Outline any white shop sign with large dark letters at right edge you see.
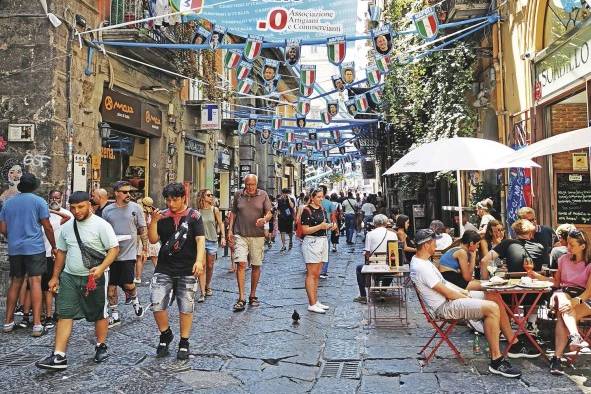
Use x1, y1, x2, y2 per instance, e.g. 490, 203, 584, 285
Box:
534, 26, 591, 100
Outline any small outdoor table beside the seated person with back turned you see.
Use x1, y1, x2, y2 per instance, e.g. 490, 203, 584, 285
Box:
361, 263, 410, 326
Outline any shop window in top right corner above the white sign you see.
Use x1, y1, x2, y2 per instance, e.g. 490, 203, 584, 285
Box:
544, 0, 591, 47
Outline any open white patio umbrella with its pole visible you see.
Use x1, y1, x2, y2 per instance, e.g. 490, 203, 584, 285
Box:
384, 137, 540, 232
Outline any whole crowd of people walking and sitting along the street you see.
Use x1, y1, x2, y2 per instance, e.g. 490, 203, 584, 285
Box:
0, 174, 591, 377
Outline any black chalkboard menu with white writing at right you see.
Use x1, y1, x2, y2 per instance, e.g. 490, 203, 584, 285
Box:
556, 173, 591, 224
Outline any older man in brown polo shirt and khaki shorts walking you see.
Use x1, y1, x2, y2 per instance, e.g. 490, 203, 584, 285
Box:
228, 174, 272, 311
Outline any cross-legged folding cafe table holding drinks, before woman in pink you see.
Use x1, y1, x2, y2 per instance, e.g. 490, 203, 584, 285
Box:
483, 286, 552, 361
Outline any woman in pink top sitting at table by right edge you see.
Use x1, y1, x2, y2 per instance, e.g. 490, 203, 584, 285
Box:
530, 230, 591, 375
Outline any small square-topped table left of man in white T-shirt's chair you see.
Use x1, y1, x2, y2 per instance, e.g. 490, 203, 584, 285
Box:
361, 264, 410, 327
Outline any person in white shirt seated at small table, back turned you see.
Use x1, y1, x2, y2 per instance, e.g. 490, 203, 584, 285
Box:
353, 214, 398, 303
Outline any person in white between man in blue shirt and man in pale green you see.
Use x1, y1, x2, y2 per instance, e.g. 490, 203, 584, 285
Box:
41, 190, 72, 329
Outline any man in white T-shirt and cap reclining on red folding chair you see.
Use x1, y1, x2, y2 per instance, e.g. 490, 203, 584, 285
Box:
410, 229, 539, 378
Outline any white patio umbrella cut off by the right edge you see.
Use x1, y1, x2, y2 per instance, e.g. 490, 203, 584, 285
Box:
505, 127, 591, 163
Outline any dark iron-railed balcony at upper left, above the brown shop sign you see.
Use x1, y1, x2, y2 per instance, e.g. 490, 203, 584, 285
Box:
99, 0, 196, 73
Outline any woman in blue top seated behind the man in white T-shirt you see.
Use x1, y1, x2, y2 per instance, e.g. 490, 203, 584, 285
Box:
439, 230, 481, 290
